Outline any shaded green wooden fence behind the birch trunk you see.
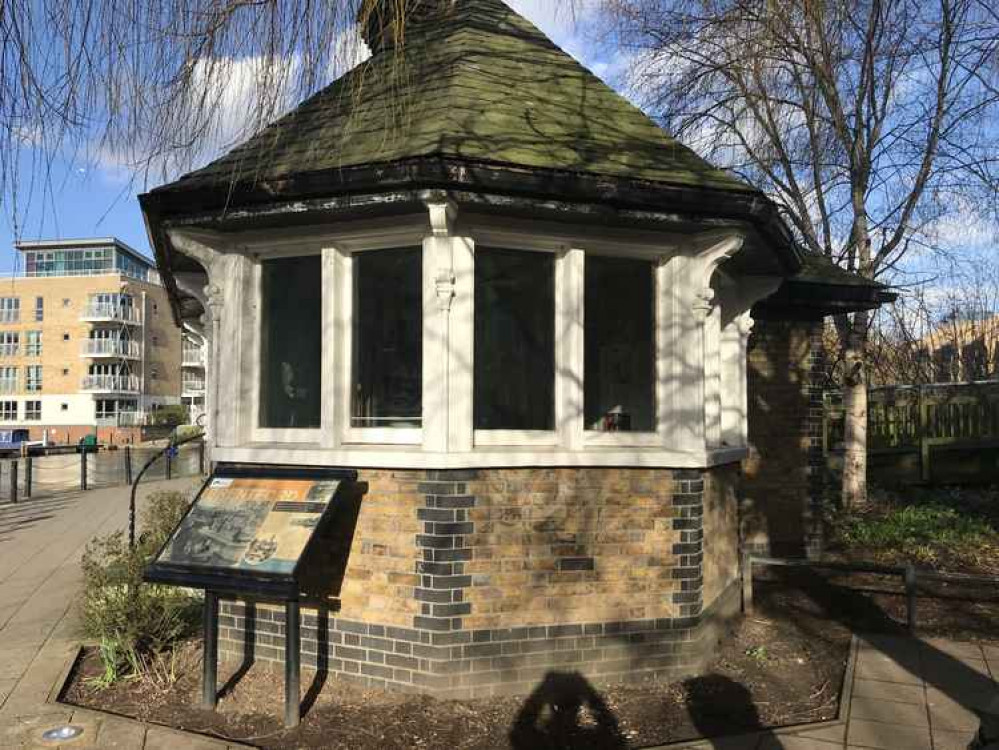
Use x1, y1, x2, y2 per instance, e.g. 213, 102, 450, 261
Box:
822, 382, 999, 484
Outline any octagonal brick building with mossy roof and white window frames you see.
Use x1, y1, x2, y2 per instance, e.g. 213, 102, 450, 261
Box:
141, 0, 887, 696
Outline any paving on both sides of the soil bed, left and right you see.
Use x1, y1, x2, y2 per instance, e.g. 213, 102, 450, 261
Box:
0, 478, 999, 750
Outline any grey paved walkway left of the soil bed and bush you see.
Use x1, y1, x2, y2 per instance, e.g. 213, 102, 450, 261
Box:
0, 477, 238, 750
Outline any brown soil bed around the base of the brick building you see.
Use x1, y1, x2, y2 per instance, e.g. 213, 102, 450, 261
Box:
63, 584, 850, 750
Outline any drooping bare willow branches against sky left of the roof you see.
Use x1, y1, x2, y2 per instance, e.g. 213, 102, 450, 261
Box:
0, 0, 438, 233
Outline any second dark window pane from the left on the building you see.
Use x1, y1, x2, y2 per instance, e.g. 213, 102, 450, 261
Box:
351, 248, 423, 427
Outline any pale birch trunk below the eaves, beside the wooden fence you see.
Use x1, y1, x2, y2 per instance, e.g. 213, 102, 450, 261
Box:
842, 312, 868, 508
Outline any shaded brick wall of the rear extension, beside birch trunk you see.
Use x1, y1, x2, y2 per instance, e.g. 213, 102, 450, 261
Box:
741, 320, 825, 555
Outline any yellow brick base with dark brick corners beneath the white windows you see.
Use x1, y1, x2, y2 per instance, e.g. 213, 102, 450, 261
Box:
220, 467, 739, 697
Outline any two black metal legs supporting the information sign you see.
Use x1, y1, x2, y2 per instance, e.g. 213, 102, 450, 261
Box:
201, 591, 302, 729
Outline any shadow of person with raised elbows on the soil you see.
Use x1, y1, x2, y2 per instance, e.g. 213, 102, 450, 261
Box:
510, 672, 628, 750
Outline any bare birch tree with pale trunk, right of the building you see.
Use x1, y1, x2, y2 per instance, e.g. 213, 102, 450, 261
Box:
603, 0, 999, 504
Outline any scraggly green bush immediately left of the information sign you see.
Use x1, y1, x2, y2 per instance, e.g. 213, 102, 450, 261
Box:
81, 492, 200, 687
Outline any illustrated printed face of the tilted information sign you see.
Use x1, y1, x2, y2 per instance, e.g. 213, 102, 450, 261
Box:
158, 477, 340, 575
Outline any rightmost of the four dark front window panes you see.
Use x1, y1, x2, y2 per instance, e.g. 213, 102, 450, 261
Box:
583, 256, 655, 432
